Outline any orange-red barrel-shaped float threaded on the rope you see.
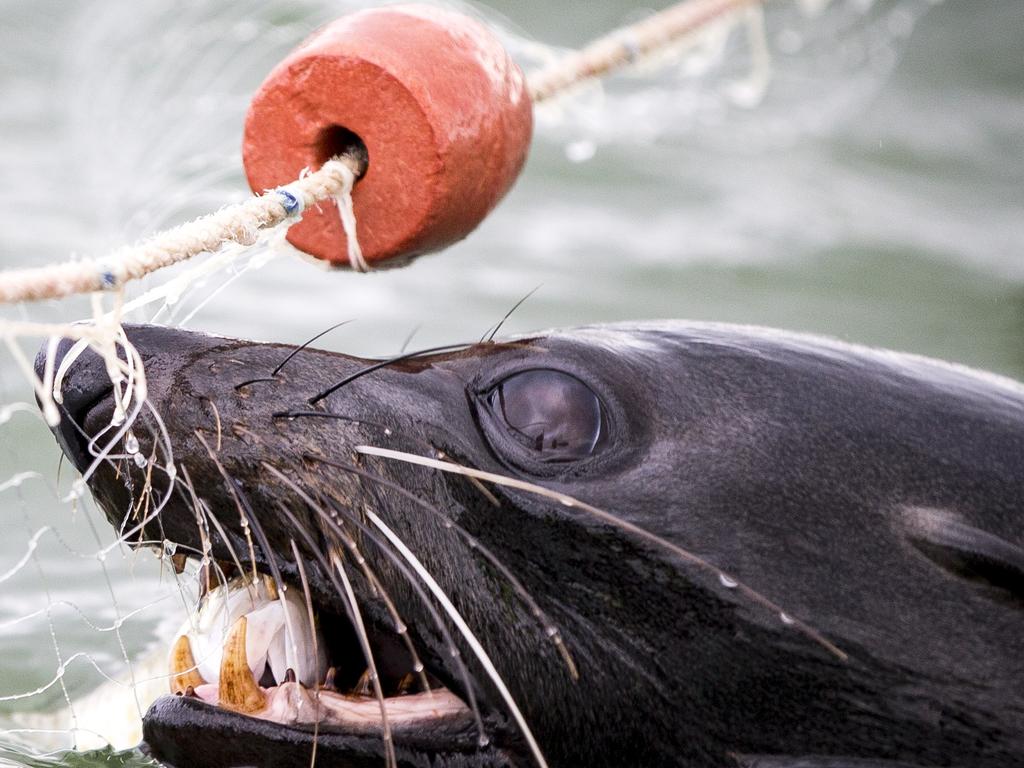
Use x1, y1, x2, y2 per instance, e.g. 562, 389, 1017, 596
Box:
243, 5, 532, 265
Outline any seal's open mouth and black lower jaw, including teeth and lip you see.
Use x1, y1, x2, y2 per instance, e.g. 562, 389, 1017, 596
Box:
143, 563, 487, 765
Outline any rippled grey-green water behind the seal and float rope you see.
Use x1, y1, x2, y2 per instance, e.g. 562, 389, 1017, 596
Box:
0, 0, 1024, 765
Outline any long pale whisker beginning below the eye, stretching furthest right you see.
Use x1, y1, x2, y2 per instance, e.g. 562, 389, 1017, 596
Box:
352, 445, 849, 662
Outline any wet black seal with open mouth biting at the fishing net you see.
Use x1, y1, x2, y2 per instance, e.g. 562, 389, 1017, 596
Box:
37, 323, 1024, 768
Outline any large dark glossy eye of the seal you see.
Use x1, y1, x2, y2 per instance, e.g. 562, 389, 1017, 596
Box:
486, 369, 604, 462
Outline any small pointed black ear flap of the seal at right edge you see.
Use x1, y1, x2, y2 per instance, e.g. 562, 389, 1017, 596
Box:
903, 507, 1024, 604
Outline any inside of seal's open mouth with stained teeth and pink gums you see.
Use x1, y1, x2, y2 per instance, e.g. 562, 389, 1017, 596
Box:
146, 561, 481, 757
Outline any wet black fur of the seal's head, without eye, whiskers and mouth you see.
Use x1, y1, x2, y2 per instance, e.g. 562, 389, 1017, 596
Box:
36, 324, 1024, 768
